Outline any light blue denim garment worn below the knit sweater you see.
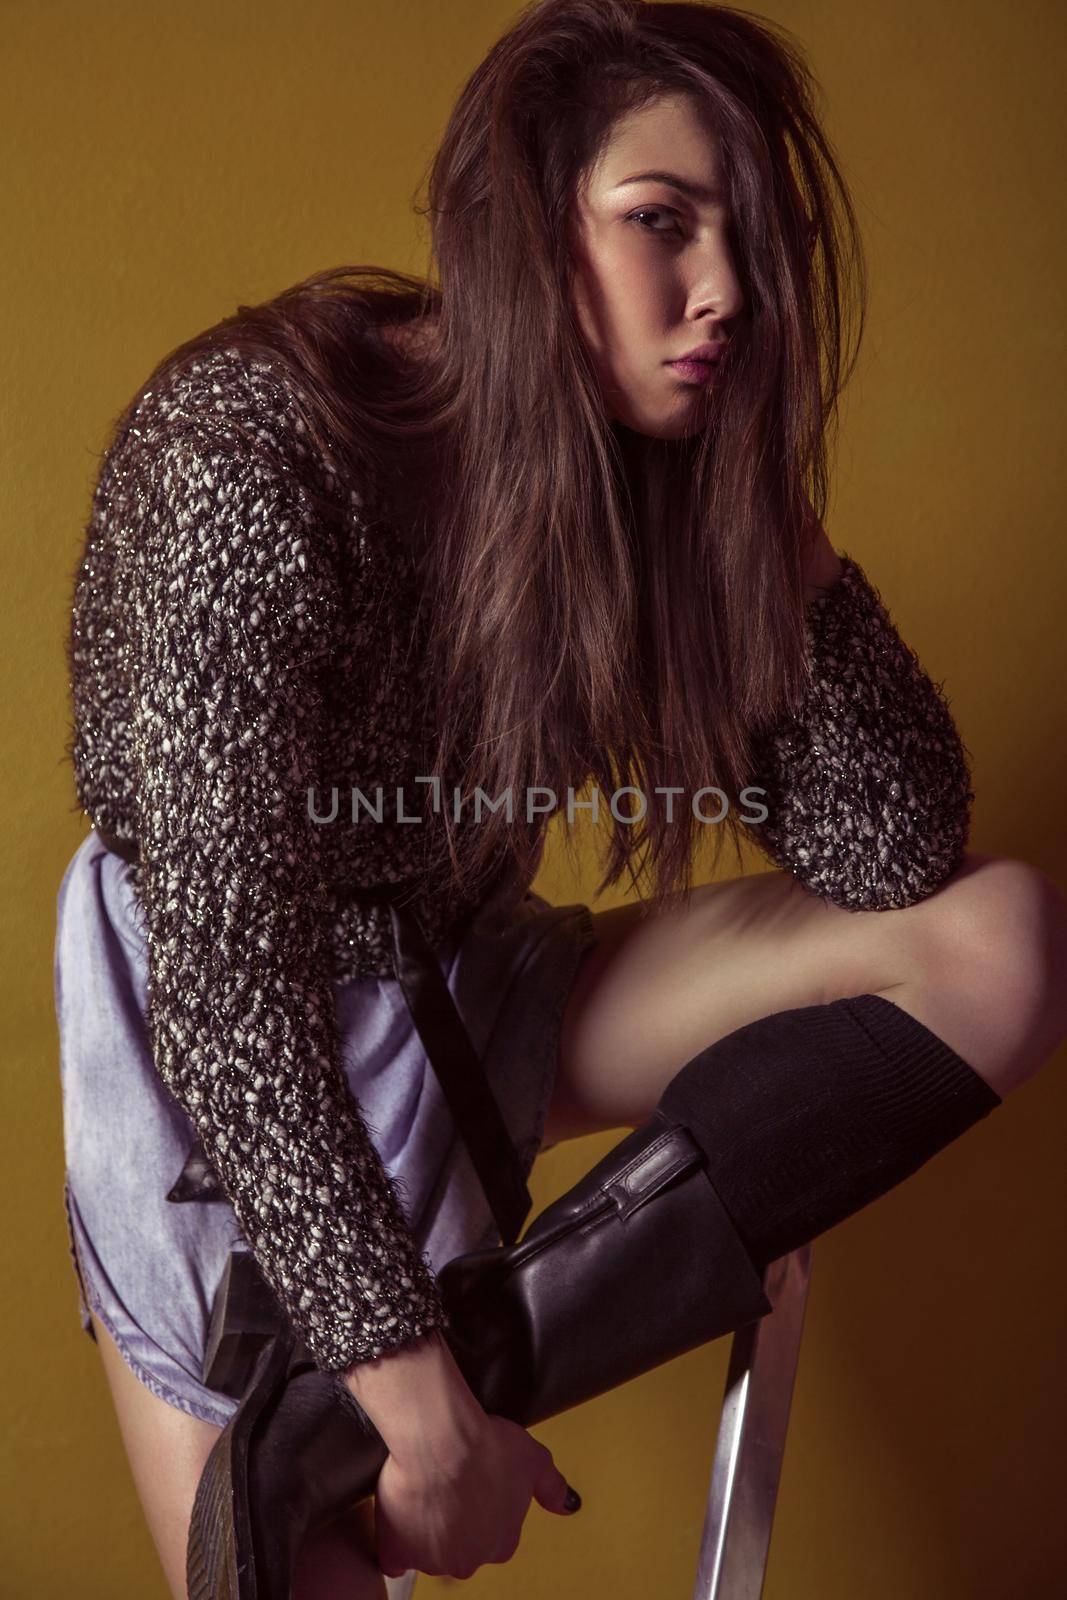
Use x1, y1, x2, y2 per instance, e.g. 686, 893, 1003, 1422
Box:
54, 832, 595, 1427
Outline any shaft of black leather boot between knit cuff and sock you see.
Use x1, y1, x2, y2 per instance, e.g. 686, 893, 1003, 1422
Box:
438, 1110, 771, 1426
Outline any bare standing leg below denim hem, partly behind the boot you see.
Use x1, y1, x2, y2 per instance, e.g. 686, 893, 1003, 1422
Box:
90, 1312, 387, 1600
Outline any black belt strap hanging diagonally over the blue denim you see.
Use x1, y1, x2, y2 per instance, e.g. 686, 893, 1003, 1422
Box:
96, 827, 533, 1245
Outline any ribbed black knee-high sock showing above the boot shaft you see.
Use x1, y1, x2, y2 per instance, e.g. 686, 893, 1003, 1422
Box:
659, 994, 1001, 1269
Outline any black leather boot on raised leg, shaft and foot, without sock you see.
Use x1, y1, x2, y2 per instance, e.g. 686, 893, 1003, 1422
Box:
187, 1114, 771, 1600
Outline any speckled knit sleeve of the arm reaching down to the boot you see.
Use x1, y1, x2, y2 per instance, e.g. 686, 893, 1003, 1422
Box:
116, 380, 448, 1371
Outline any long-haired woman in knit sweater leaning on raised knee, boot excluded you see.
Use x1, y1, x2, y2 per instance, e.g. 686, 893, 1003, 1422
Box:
56, 0, 1067, 1600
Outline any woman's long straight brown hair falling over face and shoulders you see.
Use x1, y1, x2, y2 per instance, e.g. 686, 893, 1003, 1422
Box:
97, 0, 867, 904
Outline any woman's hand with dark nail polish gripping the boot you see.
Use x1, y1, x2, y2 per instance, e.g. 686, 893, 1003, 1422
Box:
374, 1411, 581, 1578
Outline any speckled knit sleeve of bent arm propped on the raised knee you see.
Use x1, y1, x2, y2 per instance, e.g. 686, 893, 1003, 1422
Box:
749, 555, 974, 910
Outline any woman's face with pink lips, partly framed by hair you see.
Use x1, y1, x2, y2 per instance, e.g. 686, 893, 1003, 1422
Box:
573, 94, 744, 438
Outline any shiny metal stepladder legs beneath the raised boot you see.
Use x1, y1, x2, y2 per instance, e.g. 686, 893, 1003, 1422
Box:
386, 1245, 811, 1600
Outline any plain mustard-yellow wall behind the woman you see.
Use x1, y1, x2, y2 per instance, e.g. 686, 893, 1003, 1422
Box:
0, 0, 1067, 1600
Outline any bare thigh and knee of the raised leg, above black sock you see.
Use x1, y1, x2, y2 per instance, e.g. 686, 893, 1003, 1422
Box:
544, 854, 1036, 1146
